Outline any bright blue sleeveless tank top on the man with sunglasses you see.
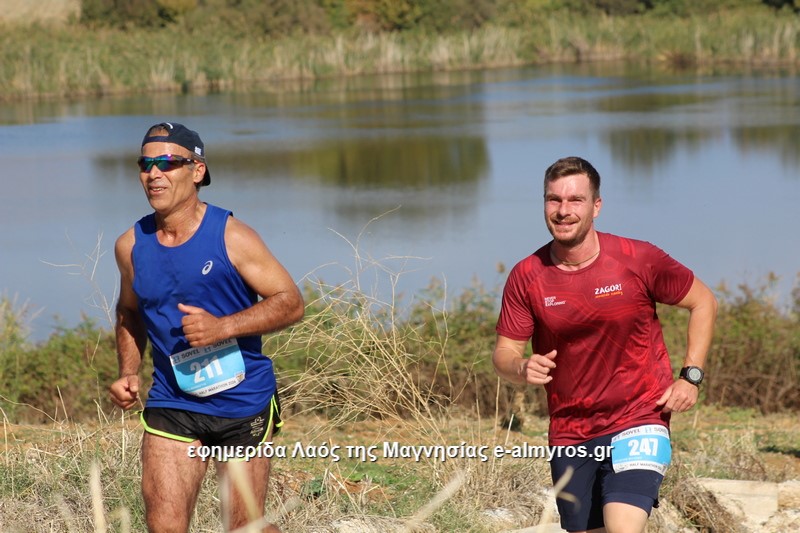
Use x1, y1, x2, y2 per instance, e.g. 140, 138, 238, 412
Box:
133, 204, 276, 418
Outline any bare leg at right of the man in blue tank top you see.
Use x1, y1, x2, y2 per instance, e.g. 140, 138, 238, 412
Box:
215, 457, 280, 533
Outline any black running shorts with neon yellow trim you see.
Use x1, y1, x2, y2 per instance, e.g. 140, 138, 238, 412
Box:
140, 392, 283, 446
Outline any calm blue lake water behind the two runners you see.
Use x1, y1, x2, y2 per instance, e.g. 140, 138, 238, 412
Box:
0, 60, 800, 339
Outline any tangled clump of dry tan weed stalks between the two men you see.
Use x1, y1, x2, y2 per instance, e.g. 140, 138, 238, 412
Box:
276, 211, 447, 442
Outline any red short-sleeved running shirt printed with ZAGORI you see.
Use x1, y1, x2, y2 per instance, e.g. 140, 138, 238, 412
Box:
496, 232, 694, 446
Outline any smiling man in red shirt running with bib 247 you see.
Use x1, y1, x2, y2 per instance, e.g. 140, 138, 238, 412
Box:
492, 157, 717, 533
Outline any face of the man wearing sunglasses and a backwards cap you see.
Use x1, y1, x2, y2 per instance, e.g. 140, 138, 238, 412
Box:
139, 142, 206, 214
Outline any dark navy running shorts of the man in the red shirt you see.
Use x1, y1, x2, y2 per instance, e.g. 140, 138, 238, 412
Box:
550, 433, 664, 531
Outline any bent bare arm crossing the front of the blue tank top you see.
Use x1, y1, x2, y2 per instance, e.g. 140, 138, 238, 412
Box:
178, 217, 304, 346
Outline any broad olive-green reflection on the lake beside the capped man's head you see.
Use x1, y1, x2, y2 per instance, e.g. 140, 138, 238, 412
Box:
93, 132, 491, 231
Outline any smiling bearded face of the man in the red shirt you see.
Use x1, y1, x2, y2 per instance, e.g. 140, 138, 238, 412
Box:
544, 174, 602, 248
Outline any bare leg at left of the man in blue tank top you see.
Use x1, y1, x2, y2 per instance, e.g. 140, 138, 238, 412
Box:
142, 432, 208, 533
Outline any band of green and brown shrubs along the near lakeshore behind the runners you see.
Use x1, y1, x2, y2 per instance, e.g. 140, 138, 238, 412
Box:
0, 268, 800, 422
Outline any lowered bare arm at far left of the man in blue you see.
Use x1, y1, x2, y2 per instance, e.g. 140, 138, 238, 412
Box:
109, 229, 147, 409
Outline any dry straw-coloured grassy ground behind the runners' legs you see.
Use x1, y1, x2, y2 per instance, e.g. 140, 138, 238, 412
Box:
0, 407, 800, 533
